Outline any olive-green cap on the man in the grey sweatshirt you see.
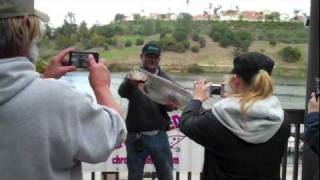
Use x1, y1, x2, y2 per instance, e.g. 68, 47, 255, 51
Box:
0, 0, 50, 22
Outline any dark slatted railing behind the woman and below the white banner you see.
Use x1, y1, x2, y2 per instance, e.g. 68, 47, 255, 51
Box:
91, 109, 305, 180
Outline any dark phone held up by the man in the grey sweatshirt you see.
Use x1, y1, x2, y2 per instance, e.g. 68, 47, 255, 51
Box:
68, 52, 99, 68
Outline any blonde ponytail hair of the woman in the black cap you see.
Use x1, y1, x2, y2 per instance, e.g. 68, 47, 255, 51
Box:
231, 70, 273, 115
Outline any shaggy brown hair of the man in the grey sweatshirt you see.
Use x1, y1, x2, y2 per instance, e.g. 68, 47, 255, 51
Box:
0, 16, 40, 58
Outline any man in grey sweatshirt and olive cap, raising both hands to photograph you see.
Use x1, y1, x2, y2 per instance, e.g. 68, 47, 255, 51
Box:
0, 0, 127, 180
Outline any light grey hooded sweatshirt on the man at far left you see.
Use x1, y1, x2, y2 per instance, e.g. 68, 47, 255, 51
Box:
0, 57, 127, 180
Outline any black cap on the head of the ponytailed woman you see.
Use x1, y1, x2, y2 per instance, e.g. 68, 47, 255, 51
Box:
231, 52, 274, 84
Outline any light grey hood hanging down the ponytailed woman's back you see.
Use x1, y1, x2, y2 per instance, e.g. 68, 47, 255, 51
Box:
212, 96, 284, 144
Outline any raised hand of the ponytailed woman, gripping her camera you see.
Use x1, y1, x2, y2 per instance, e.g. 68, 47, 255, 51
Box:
193, 79, 211, 102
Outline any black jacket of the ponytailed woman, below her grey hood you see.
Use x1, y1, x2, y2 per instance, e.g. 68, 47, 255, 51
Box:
180, 100, 290, 180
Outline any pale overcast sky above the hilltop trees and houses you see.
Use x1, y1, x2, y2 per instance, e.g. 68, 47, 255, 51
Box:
35, 0, 310, 26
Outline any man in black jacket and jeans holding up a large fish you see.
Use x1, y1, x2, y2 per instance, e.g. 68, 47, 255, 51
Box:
118, 43, 176, 180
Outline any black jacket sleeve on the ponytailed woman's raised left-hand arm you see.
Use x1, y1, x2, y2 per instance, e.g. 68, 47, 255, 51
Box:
180, 100, 219, 149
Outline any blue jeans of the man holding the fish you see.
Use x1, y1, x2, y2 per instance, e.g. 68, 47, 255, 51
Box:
126, 131, 173, 180
